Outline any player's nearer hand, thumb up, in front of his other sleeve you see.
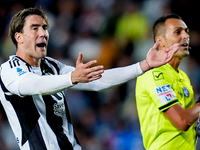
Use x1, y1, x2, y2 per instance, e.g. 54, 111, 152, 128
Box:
71, 53, 104, 84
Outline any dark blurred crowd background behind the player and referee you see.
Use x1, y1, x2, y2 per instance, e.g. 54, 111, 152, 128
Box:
0, 0, 200, 150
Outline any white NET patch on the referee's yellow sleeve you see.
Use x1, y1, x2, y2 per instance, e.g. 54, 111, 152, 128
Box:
155, 84, 176, 104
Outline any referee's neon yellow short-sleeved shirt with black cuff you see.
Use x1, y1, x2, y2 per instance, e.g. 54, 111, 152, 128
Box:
136, 64, 196, 150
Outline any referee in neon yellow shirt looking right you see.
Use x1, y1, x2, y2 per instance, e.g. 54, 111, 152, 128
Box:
136, 14, 200, 150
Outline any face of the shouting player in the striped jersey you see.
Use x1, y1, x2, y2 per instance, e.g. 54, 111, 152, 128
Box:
22, 15, 49, 59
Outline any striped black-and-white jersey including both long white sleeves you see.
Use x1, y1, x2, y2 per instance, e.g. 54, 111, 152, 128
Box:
0, 56, 143, 150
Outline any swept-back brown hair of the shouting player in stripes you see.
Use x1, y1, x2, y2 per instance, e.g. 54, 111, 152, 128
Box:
9, 8, 49, 47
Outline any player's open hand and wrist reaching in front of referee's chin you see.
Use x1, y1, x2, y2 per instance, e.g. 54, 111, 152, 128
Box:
140, 42, 180, 72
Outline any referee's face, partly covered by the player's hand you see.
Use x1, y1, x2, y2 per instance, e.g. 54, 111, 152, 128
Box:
164, 18, 189, 58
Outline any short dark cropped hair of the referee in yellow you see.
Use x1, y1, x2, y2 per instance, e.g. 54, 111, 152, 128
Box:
153, 13, 182, 41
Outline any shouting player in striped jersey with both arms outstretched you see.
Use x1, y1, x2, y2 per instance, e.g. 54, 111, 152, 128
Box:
0, 8, 180, 150
